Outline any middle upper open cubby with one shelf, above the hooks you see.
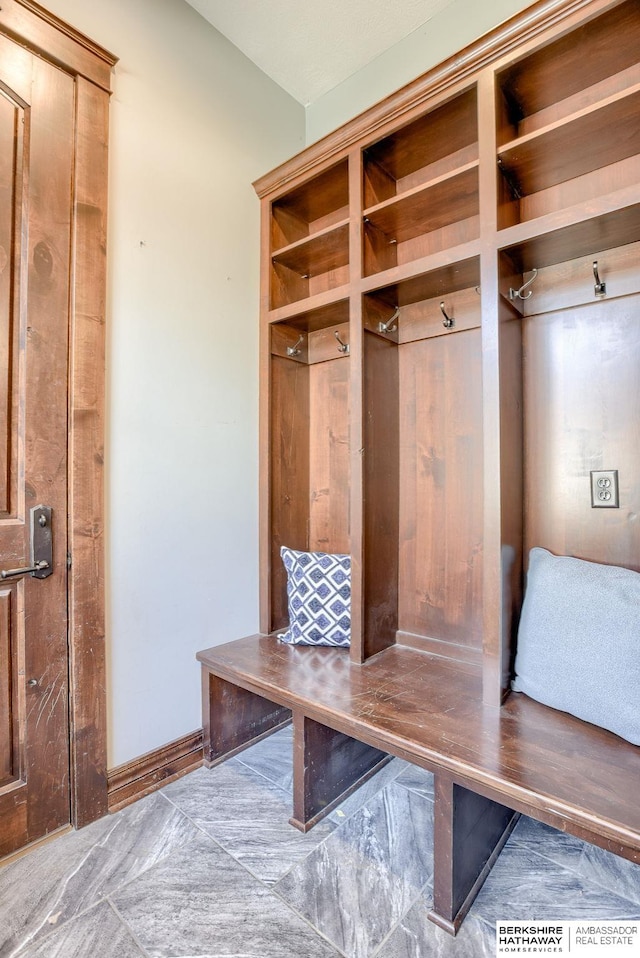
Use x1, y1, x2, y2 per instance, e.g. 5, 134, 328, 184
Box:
363, 86, 479, 276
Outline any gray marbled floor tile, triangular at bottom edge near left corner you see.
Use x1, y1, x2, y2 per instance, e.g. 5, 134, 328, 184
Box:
14, 901, 144, 958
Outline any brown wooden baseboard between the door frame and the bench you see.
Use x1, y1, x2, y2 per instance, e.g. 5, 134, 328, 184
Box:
107, 729, 203, 812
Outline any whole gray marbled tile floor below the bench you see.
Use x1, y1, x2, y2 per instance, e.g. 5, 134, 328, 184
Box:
0, 729, 640, 958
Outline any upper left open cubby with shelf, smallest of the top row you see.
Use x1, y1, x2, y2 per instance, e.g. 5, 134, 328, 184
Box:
271, 160, 349, 309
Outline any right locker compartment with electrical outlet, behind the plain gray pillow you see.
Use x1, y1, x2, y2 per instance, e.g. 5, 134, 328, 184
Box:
492, 215, 640, 691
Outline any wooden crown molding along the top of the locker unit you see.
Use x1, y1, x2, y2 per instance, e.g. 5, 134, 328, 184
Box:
253, 0, 611, 199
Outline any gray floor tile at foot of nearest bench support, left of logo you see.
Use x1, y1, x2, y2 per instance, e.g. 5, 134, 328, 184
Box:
375, 899, 496, 958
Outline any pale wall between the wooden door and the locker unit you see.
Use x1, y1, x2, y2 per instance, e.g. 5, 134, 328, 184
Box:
46, 0, 304, 767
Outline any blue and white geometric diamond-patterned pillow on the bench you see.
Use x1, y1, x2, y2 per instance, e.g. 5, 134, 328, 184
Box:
279, 546, 351, 649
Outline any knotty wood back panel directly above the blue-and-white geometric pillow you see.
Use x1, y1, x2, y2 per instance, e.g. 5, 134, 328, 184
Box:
308, 358, 350, 553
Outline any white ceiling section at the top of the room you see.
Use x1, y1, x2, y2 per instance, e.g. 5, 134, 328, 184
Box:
182, 0, 453, 106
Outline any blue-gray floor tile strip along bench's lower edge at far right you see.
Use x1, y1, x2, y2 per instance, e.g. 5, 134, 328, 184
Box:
509, 815, 640, 906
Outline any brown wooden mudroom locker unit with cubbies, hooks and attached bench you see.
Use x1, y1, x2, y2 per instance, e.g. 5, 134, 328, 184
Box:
198, 0, 640, 933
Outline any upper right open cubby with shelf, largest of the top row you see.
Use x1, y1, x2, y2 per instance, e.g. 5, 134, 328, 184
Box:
497, 0, 640, 229
